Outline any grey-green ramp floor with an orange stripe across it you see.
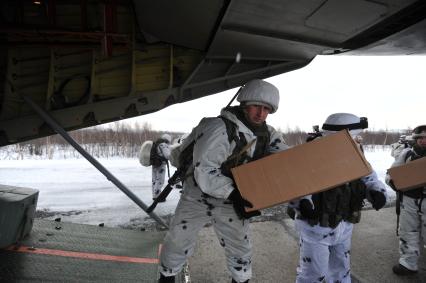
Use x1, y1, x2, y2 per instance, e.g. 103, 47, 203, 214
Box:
0, 219, 165, 282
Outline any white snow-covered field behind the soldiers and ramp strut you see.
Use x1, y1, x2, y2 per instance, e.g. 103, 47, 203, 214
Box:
0, 147, 395, 227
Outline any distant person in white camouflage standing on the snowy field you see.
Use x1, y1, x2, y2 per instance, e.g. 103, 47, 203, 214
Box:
150, 134, 172, 200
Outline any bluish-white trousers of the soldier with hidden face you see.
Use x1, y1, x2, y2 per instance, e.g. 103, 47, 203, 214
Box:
296, 220, 353, 283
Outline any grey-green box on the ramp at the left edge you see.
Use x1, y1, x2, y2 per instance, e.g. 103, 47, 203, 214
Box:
0, 185, 38, 249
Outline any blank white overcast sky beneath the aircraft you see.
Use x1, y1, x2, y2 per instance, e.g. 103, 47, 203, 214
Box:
121, 56, 426, 135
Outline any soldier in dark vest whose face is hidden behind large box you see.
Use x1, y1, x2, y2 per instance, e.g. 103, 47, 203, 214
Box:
289, 113, 386, 283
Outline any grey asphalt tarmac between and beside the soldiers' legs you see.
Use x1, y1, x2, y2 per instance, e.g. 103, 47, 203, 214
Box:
189, 207, 426, 283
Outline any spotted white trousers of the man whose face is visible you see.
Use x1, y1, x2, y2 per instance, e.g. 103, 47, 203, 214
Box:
160, 192, 252, 282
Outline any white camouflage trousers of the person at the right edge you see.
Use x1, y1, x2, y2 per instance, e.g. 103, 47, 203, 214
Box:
399, 195, 426, 270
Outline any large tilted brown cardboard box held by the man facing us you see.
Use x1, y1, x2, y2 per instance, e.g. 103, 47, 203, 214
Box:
232, 130, 371, 211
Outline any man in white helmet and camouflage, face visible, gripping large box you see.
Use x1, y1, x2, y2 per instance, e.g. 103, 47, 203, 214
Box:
159, 80, 287, 282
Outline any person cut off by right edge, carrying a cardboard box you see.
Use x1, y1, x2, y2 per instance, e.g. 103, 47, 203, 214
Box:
386, 125, 426, 276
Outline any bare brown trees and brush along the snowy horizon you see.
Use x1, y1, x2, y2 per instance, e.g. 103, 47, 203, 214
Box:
2, 122, 410, 159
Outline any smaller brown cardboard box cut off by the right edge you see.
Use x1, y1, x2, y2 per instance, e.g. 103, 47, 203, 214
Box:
388, 157, 426, 191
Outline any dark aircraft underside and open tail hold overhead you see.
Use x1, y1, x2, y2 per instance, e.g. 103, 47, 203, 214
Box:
0, 0, 426, 146
